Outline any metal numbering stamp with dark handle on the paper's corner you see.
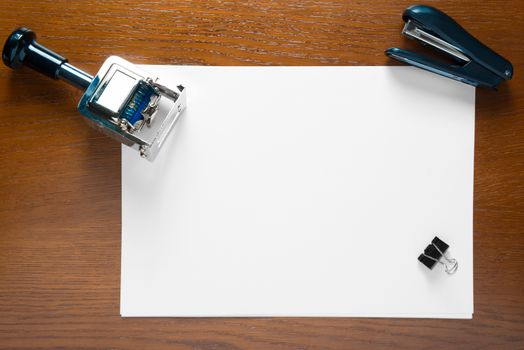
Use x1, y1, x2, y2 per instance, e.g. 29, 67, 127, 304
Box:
2, 28, 186, 160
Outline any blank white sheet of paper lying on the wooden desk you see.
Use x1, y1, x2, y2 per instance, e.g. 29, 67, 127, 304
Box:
121, 66, 475, 318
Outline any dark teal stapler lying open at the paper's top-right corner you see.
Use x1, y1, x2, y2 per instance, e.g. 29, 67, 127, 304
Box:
385, 5, 513, 89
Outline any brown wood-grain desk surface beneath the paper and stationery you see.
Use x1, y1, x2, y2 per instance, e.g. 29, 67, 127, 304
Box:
0, 0, 524, 350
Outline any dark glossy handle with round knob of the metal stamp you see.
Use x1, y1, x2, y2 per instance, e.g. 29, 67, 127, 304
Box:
2, 27, 93, 90
